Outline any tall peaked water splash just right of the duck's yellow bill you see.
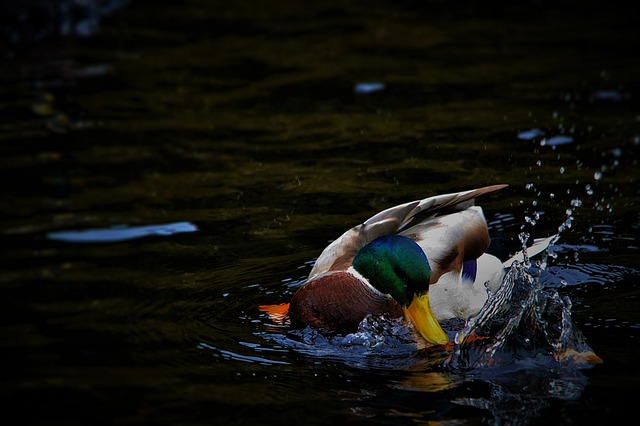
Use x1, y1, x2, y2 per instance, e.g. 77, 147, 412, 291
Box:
446, 262, 601, 370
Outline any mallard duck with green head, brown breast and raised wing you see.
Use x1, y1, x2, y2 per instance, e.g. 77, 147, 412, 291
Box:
261, 184, 555, 346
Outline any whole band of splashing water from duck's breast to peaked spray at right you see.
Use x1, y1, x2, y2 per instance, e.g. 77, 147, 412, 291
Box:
260, 258, 601, 372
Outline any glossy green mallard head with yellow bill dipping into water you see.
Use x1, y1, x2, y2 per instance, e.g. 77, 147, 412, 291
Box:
352, 235, 449, 345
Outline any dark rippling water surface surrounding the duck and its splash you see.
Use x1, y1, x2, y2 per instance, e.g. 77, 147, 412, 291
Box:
0, 0, 640, 424
